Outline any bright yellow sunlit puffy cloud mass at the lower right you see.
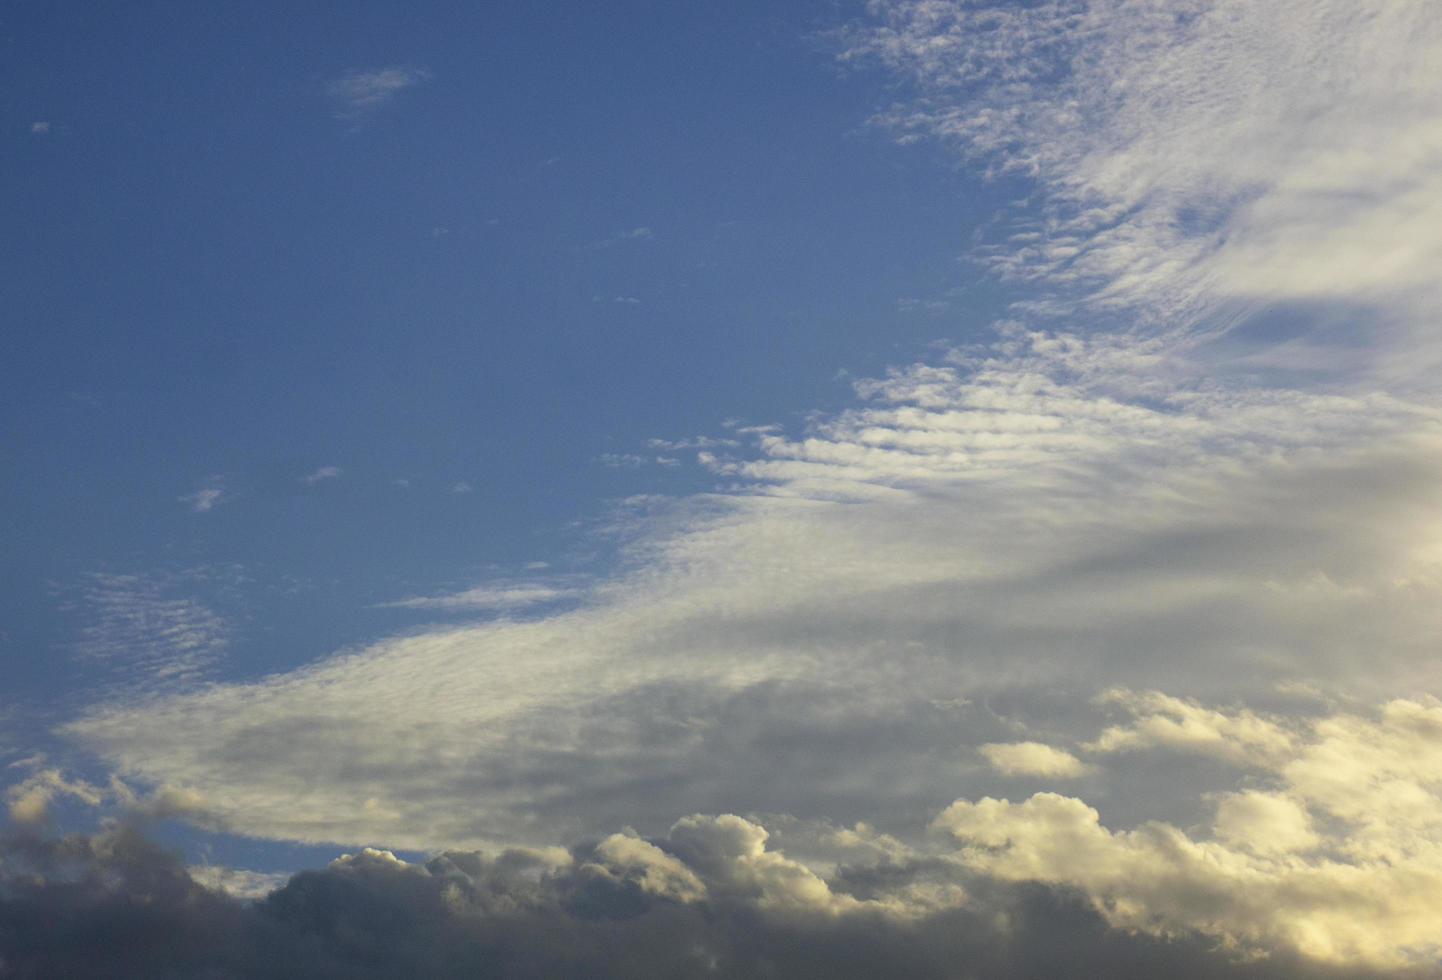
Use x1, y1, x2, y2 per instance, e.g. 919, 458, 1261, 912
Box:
934, 695, 1442, 967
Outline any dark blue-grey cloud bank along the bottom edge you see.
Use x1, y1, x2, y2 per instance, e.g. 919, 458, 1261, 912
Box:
0, 827, 1418, 980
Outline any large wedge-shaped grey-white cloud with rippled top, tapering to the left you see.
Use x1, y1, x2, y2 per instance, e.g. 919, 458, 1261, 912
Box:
66, 343, 1442, 849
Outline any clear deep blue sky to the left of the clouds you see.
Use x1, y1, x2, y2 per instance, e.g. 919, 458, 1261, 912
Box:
4, 4, 1015, 693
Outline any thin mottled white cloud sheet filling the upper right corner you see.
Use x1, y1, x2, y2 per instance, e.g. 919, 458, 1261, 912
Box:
839, 0, 1442, 380
